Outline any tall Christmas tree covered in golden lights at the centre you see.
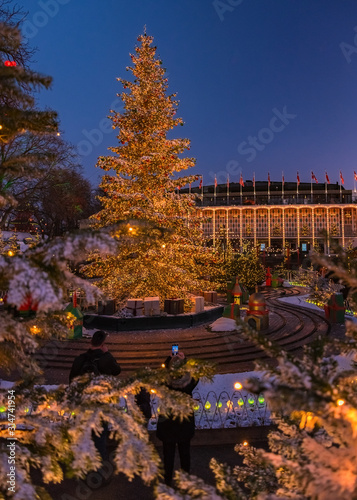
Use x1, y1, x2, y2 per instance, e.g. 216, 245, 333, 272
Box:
85, 34, 219, 300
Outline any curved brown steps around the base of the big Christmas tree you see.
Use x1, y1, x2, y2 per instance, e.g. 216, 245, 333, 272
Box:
40, 288, 331, 383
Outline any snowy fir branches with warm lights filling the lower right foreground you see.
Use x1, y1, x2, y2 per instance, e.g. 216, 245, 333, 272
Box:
162, 244, 357, 500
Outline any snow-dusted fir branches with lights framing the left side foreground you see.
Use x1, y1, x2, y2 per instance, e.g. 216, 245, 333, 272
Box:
0, 13, 214, 500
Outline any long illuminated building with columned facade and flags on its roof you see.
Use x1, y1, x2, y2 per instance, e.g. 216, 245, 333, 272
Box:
182, 181, 357, 254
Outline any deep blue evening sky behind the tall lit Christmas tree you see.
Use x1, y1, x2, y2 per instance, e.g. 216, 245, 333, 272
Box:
19, 0, 357, 188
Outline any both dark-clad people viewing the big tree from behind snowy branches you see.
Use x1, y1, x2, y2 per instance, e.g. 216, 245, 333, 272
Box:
69, 330, 198, 485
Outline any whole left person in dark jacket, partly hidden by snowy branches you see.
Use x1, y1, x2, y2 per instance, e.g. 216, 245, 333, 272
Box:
69, 330, 121, 468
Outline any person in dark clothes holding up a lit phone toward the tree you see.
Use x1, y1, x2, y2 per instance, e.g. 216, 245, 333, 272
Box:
156, 352, 198, 486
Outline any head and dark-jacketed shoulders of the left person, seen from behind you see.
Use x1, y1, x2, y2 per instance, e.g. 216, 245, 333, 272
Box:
69, 330, 121, 383
